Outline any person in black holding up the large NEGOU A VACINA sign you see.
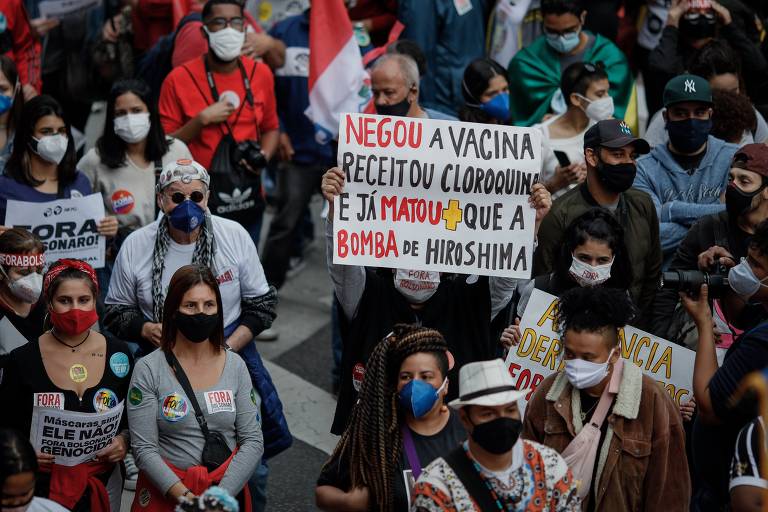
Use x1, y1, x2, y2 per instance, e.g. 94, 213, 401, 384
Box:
321, 167, 552, 435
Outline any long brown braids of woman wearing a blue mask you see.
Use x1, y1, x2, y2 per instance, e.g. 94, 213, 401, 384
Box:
323, 324, 448, 512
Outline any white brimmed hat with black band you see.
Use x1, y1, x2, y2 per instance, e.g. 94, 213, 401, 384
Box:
448, 359, 530, 409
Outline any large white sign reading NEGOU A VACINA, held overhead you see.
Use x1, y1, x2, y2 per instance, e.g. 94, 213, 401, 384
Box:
333, 114, 541, 278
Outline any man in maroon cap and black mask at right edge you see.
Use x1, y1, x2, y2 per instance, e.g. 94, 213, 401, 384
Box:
653, 144, 768, 345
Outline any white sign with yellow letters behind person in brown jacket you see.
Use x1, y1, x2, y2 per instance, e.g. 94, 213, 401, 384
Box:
506, 289, 696, 404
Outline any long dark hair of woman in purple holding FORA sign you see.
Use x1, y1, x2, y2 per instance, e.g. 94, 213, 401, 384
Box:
5, 94, 77, 188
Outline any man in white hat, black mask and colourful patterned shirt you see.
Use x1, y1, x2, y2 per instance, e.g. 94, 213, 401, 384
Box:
411, 359, 581, 512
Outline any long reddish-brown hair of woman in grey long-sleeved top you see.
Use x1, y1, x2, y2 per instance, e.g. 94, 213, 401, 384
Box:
160, 265, 224, 352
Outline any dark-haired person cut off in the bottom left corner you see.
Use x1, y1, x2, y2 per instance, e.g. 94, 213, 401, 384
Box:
0, 428, 67, 512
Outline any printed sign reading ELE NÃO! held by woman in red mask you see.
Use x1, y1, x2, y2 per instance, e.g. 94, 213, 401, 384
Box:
29, 402, 124, 466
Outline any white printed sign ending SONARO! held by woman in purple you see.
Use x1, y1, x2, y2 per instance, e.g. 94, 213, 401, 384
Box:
5, 194, 105, 268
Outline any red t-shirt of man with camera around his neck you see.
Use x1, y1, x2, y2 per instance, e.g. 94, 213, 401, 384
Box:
159, 57, 279, 169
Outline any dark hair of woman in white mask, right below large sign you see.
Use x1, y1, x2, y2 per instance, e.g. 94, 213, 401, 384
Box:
555, 208, 633, 290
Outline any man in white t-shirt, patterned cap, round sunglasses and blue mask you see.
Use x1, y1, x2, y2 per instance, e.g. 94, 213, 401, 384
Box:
104, 160, 291, 510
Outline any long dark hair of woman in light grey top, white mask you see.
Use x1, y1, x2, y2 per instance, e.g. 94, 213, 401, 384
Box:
96, 79, 169, 169
